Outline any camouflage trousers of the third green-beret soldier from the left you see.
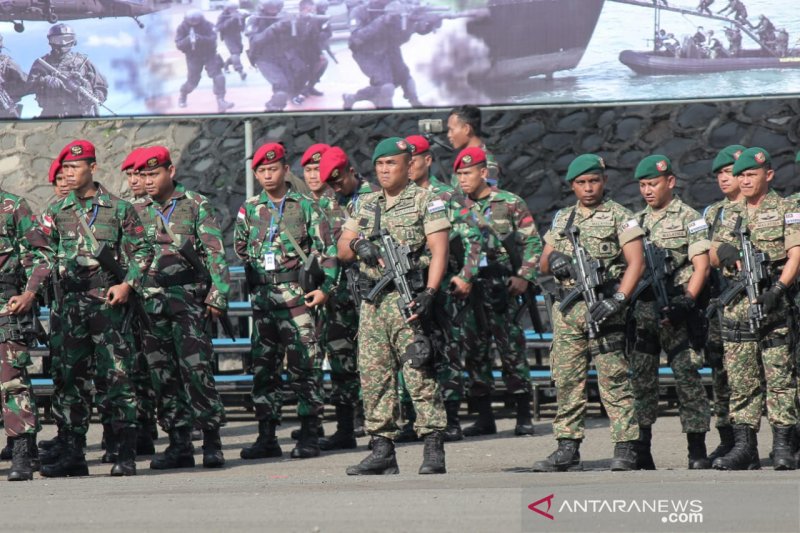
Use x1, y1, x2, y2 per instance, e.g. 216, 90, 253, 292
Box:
628, 301, 711, 433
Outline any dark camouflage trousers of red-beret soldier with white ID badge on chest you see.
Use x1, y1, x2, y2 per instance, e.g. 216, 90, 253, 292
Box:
250, 289, 324, 422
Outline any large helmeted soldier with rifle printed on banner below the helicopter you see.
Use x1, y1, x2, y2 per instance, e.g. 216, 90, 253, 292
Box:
28, 24, 108, 118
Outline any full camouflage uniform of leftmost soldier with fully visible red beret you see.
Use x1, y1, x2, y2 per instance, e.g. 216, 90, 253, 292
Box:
42, 185, 153, 435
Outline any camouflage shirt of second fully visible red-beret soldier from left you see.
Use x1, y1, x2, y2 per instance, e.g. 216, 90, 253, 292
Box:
134, 183, 230, 310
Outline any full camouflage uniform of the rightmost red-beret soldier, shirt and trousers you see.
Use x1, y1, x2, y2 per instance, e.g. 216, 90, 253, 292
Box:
463, 187, 542, 398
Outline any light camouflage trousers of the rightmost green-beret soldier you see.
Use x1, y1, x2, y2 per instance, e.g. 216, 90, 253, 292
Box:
722, 298, 797, 431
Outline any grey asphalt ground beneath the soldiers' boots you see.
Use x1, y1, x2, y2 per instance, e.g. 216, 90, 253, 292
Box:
6, 409, 800, 532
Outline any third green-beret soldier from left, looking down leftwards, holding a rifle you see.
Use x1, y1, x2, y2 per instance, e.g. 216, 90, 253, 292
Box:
628, 155, 711, 470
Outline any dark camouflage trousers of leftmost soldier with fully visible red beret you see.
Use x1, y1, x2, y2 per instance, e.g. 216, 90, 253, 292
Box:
60, 292, 136, 434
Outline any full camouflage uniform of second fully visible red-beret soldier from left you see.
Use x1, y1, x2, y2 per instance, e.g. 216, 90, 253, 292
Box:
137, 183, 230, 432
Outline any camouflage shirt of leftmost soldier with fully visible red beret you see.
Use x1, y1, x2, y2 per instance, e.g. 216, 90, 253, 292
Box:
42, 183, 153, 297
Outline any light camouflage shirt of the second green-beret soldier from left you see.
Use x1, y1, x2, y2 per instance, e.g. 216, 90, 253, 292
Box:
544, 198, 644, 285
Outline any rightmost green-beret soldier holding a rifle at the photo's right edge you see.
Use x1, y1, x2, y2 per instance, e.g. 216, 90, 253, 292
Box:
711, 147, 800, 470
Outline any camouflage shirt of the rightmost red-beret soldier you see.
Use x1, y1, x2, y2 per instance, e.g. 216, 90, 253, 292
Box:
466, 187, 542, 281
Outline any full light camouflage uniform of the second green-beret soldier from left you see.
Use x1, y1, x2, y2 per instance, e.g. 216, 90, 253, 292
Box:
544, 199, 644, 442
